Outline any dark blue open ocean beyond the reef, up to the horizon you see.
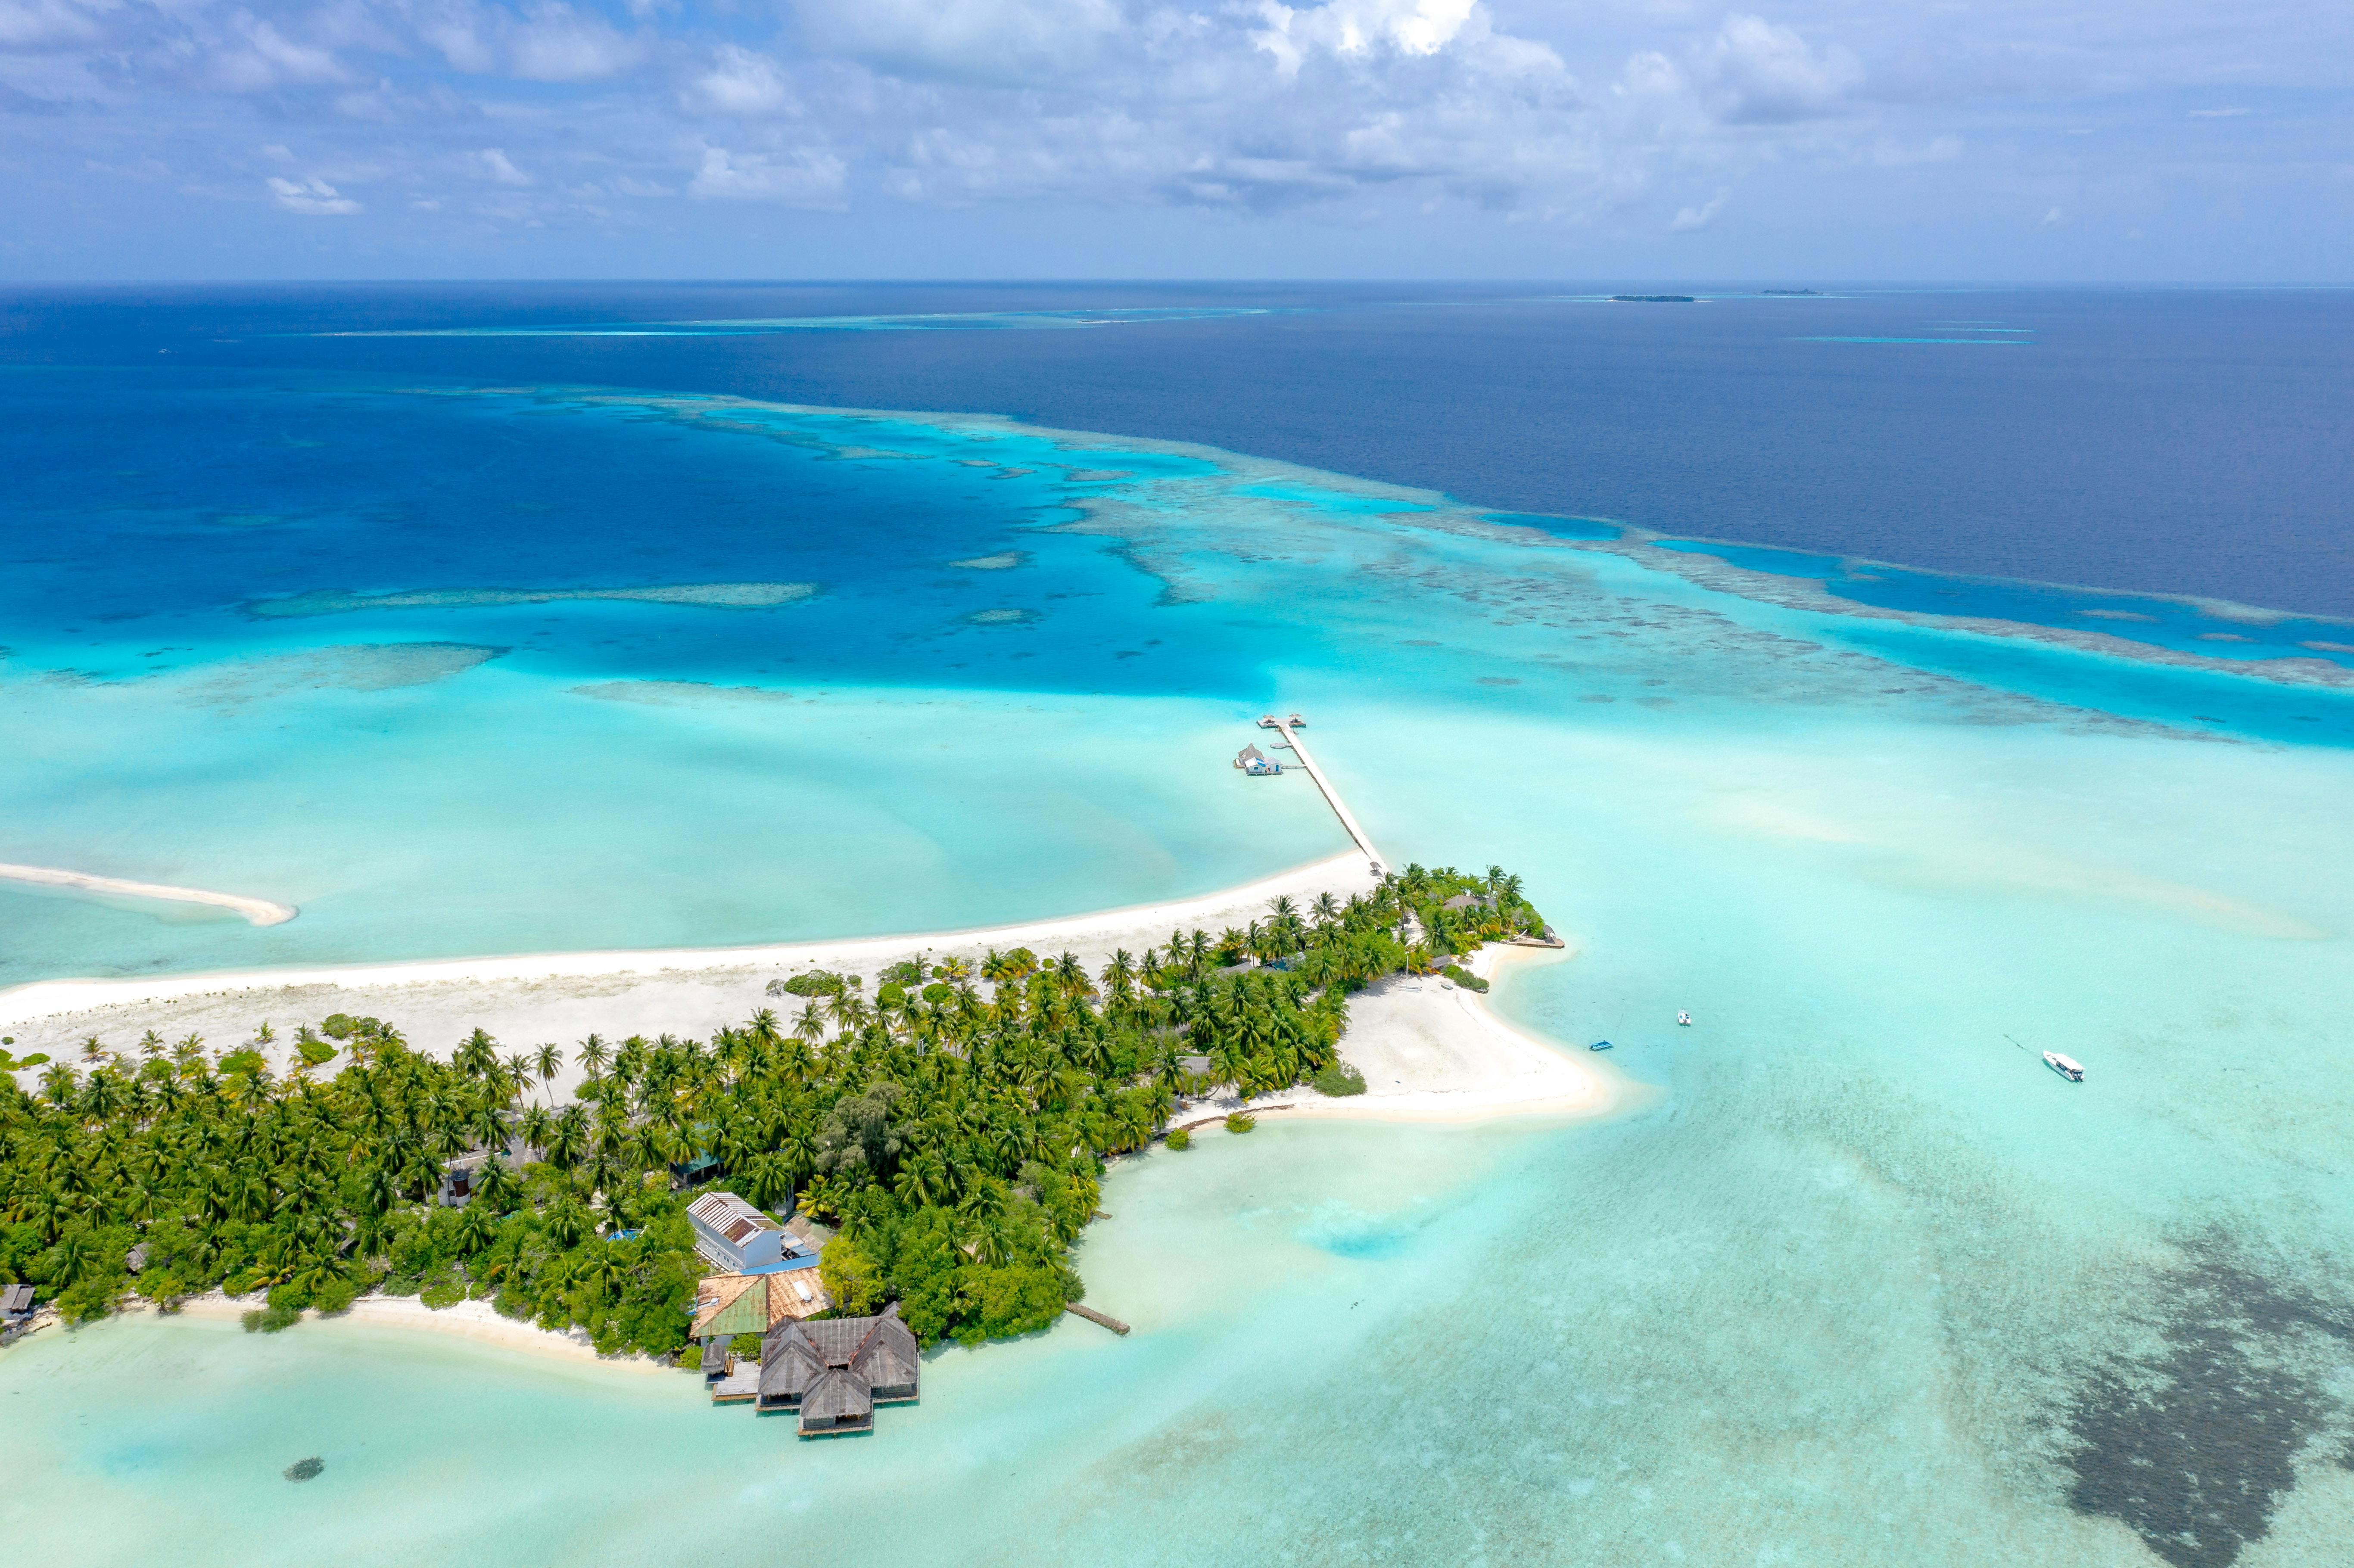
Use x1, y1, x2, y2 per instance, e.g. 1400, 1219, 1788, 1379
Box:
0, 285, 2354, 617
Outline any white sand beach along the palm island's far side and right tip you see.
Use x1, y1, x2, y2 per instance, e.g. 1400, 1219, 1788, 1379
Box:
0, 852, 1634, 1121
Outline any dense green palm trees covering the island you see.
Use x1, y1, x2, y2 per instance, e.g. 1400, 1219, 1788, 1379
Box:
0, 866, 1558, 1359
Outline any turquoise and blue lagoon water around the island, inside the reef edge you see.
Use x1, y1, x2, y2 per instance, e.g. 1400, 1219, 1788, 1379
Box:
0, 376, 2354, 1566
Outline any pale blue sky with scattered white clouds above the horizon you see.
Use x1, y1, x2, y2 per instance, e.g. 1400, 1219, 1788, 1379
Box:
0, 0, 2354, 283
